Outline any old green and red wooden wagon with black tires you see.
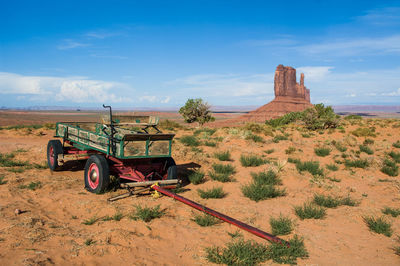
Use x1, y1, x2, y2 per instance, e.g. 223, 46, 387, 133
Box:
47, 105, 178, 194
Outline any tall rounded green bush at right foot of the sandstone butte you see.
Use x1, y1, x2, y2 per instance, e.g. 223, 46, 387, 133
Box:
302, 103, 340, 130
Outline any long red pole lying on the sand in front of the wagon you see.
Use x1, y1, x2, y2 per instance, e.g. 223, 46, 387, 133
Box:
151, 184, 289, 247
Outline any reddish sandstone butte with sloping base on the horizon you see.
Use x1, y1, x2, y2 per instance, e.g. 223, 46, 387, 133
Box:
240, 65, 312, 122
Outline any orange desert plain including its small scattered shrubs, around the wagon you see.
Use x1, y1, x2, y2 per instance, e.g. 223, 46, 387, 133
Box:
0, 111, 400, 265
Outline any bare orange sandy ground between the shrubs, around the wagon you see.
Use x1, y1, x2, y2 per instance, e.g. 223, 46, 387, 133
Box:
0, 113, 400, 265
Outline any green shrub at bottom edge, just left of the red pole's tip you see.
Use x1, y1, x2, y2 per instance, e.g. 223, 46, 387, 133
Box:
205, 239, 269, 265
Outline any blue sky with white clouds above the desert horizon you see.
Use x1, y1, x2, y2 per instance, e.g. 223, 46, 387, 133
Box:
0, 0, 400, 108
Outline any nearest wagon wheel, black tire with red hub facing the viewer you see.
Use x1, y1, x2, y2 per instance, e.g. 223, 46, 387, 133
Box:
84, 154, 110, 194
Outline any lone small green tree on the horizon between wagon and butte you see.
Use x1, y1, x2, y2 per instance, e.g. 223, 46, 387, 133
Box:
179, 98, 215, 126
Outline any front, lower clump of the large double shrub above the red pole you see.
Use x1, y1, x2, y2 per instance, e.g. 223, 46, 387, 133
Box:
241, 181, 286, 202
